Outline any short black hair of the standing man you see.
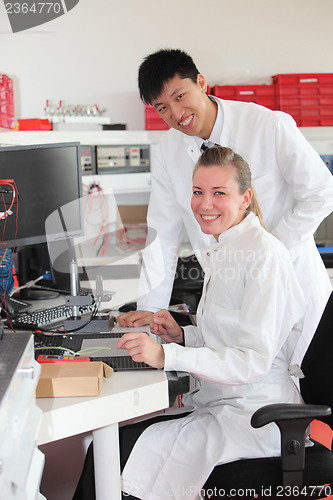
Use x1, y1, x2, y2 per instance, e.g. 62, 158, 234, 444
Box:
138, 49, 199, 104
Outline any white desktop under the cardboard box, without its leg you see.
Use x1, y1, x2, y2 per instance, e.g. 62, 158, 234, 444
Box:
37, 370, 169, 445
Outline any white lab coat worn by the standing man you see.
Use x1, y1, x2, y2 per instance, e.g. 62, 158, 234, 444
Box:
138, 98, 333, 364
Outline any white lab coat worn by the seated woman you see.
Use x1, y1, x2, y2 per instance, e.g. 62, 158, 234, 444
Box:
123, 214, 305, 500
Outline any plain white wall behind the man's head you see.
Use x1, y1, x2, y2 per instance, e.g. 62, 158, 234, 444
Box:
0, 0, 333, 130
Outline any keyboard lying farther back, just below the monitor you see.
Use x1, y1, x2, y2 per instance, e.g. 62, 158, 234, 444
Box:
6, 304, 95, 330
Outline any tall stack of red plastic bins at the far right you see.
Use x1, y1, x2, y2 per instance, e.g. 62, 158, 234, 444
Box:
273, 73, 333, 127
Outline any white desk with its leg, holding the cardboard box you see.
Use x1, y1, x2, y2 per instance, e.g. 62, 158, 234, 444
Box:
37, 370, 169, 500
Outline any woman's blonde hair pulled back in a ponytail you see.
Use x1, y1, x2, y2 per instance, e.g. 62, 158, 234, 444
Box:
193, 146, 265, 227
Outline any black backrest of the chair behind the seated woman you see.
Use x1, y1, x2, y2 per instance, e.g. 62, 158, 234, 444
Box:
300, 293, 333, 429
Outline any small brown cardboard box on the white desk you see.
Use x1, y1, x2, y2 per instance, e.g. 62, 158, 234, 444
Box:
36, 361, 113, 398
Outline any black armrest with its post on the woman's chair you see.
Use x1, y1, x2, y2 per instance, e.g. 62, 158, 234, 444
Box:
251, 403, 332, 488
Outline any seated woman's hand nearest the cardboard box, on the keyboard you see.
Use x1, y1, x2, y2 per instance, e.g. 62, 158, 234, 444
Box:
117, 332, 164, 368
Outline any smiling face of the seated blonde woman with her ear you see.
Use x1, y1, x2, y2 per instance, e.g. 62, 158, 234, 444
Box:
191, 165, 252, 241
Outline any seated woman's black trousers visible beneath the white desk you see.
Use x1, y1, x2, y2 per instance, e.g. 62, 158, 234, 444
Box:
73, 413, 192, 500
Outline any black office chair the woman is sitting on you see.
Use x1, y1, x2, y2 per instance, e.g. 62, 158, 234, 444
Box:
203, 293, 333, 500
